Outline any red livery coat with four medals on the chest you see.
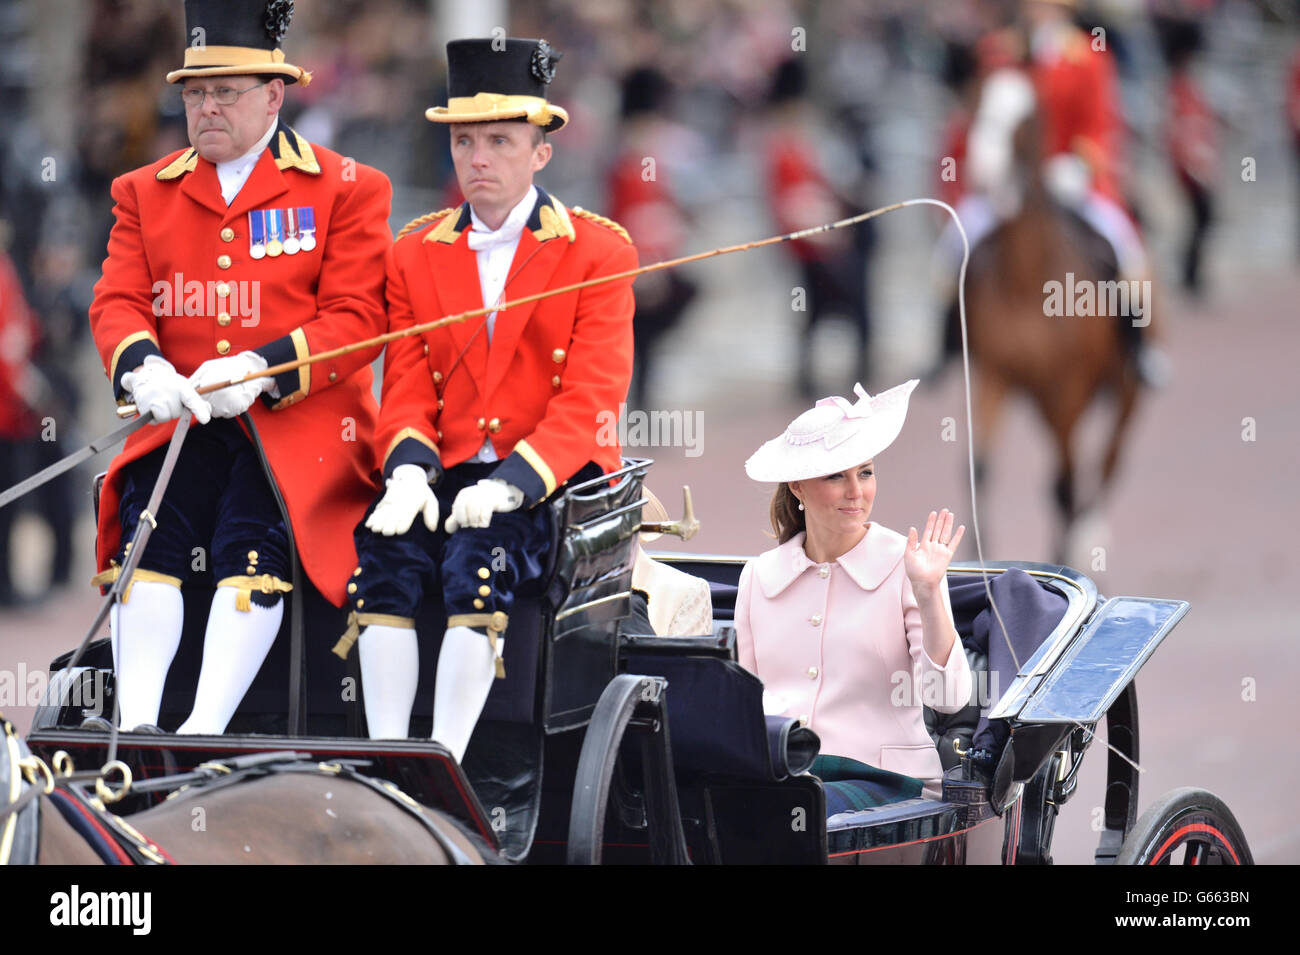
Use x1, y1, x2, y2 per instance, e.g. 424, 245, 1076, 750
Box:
90, 123, 393, 605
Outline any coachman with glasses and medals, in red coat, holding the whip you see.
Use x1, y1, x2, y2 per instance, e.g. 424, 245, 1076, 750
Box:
90, 0, 391, 733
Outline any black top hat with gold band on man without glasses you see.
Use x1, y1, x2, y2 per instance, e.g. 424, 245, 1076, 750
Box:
424, 38, 568, 133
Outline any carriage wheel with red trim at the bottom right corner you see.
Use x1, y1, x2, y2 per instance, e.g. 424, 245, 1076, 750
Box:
1115, 787, 1255, 865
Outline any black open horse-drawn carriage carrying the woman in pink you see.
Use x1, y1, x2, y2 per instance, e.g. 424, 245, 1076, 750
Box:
17, 460, 1251, 864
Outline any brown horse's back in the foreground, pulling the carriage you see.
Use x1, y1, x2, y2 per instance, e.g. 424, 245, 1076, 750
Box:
21, 753, 494, 865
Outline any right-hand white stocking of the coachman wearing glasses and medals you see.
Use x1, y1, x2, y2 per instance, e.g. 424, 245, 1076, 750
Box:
177, 587, 285, 734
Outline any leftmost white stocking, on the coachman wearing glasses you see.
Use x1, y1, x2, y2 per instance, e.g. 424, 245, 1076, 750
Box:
104, 581, 185, 730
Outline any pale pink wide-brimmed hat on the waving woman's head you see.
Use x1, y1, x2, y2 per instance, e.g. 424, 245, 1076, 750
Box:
745, 378, 918, 482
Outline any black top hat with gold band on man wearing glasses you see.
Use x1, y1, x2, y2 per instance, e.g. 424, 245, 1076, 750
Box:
166, 0, 312, 86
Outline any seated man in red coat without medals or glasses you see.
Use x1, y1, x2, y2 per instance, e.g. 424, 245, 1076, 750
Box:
335, 39, 637, 759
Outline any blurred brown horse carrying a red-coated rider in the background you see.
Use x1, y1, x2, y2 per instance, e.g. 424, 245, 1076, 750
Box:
966, 80, 1152, 563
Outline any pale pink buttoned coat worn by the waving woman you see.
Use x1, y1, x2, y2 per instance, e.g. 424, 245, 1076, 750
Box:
736, 524, 971, 795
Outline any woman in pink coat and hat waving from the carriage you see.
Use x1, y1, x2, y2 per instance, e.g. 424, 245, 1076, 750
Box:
736, 381, 971, 798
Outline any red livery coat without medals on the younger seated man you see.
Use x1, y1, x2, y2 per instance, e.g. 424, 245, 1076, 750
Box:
376, 188, 637, 504
